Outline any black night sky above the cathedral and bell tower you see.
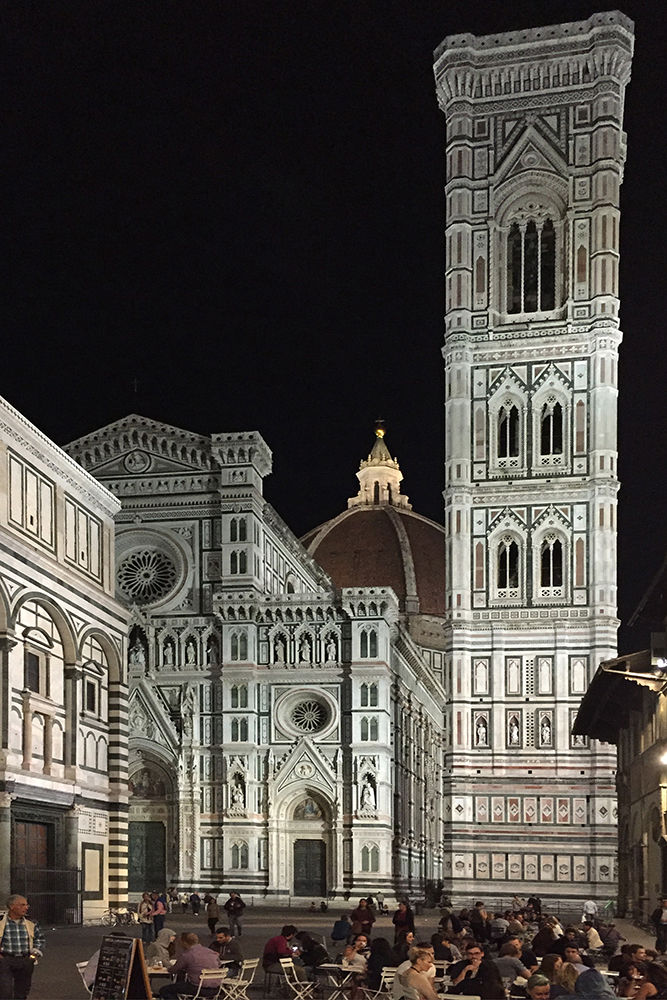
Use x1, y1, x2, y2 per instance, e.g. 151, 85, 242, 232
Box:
0, 0, 667, 649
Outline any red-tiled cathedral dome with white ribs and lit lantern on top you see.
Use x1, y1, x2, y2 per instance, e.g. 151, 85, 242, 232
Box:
301, 427, 445, 617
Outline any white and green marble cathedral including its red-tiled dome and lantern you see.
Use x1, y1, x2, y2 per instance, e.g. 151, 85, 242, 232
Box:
67, 416, 445, 898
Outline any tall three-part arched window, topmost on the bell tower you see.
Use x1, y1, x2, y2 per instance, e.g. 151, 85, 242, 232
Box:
507, 219, 556, 313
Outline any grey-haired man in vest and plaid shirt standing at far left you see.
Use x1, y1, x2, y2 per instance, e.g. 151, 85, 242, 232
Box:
0, 895, 46, 1000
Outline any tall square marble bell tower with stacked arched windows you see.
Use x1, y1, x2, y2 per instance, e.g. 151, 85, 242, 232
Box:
435, 11, 633, 899
